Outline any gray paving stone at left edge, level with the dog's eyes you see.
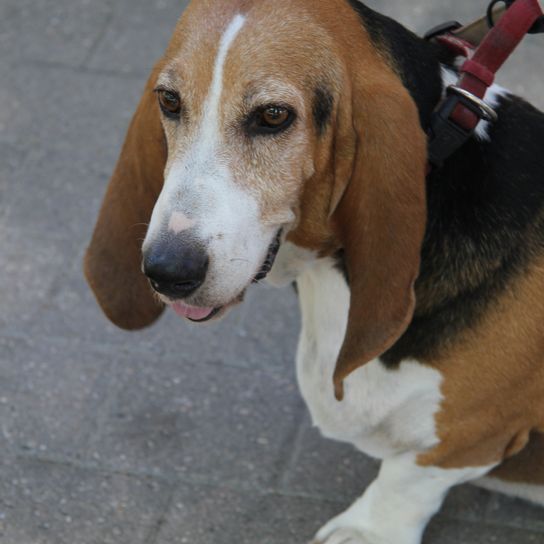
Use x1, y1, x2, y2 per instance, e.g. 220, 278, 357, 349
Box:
0, 63, 147, 241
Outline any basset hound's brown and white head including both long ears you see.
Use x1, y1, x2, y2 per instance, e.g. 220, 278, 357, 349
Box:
85, 0, 426, 396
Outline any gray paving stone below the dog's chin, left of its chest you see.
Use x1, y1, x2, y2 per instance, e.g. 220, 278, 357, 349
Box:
89, 347, 301, 488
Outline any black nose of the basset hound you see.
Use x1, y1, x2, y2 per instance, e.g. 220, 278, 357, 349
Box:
143, 239, 208, 299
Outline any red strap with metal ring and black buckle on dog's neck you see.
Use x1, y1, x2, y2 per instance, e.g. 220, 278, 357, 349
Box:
427, 0, 544, 167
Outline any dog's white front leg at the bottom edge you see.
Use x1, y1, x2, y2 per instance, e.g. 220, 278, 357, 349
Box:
312, 454, 493, 544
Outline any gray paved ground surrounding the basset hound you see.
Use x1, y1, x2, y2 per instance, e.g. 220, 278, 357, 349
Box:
0, 0, 544, 544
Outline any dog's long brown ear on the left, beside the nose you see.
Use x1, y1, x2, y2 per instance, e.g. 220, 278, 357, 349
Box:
84, 65, 167, 329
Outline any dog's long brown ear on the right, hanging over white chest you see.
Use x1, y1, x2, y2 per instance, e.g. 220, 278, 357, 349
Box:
332, 73, 427, 400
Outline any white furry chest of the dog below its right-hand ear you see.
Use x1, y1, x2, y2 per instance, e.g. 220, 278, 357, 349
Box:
297, 259, 442, 458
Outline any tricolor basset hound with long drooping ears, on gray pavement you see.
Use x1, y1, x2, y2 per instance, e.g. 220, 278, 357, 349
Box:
85, 0, 544, 544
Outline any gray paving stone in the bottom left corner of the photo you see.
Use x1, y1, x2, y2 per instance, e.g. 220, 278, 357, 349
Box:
0, 458, 171, 544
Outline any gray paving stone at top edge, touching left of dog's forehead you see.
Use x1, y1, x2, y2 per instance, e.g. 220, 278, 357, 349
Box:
84, 0, 188, 75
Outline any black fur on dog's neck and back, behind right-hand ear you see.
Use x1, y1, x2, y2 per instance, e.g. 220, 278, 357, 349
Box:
349, 0, 544, 366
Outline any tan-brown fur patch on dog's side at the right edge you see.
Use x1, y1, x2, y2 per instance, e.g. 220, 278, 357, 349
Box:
419, 258, 544, 474
